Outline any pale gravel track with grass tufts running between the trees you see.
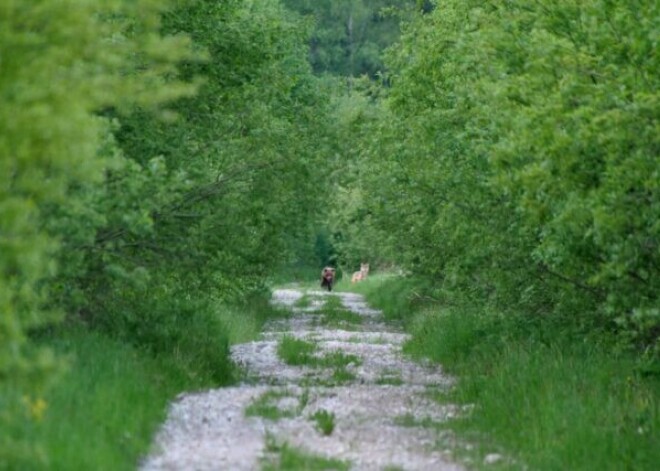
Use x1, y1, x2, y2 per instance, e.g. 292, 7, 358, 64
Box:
141, 289, 462, 471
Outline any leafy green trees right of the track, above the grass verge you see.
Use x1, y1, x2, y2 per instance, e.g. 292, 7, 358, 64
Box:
338, 0, 660, 348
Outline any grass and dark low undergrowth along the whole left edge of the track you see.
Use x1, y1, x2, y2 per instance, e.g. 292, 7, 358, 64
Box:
0, 297, 283, 471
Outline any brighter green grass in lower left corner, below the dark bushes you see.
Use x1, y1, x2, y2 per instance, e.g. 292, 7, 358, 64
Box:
0, 331, 200, 471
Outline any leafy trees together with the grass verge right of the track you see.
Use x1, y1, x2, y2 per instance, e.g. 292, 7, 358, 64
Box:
324, 0, 660, 470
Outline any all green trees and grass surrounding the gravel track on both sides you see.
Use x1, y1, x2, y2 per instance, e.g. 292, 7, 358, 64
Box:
0, 0, 660, 469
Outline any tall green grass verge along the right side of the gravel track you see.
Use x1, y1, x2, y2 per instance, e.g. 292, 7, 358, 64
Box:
350, 277, 660, 471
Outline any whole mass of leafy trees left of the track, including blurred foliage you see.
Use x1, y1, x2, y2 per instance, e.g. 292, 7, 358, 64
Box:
0, 0, 330, 465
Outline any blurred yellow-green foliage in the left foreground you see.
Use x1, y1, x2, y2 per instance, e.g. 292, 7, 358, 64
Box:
0, 0, 193, 460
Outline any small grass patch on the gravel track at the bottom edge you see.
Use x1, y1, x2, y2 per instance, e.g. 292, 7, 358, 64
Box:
262, 439, 350, 471
